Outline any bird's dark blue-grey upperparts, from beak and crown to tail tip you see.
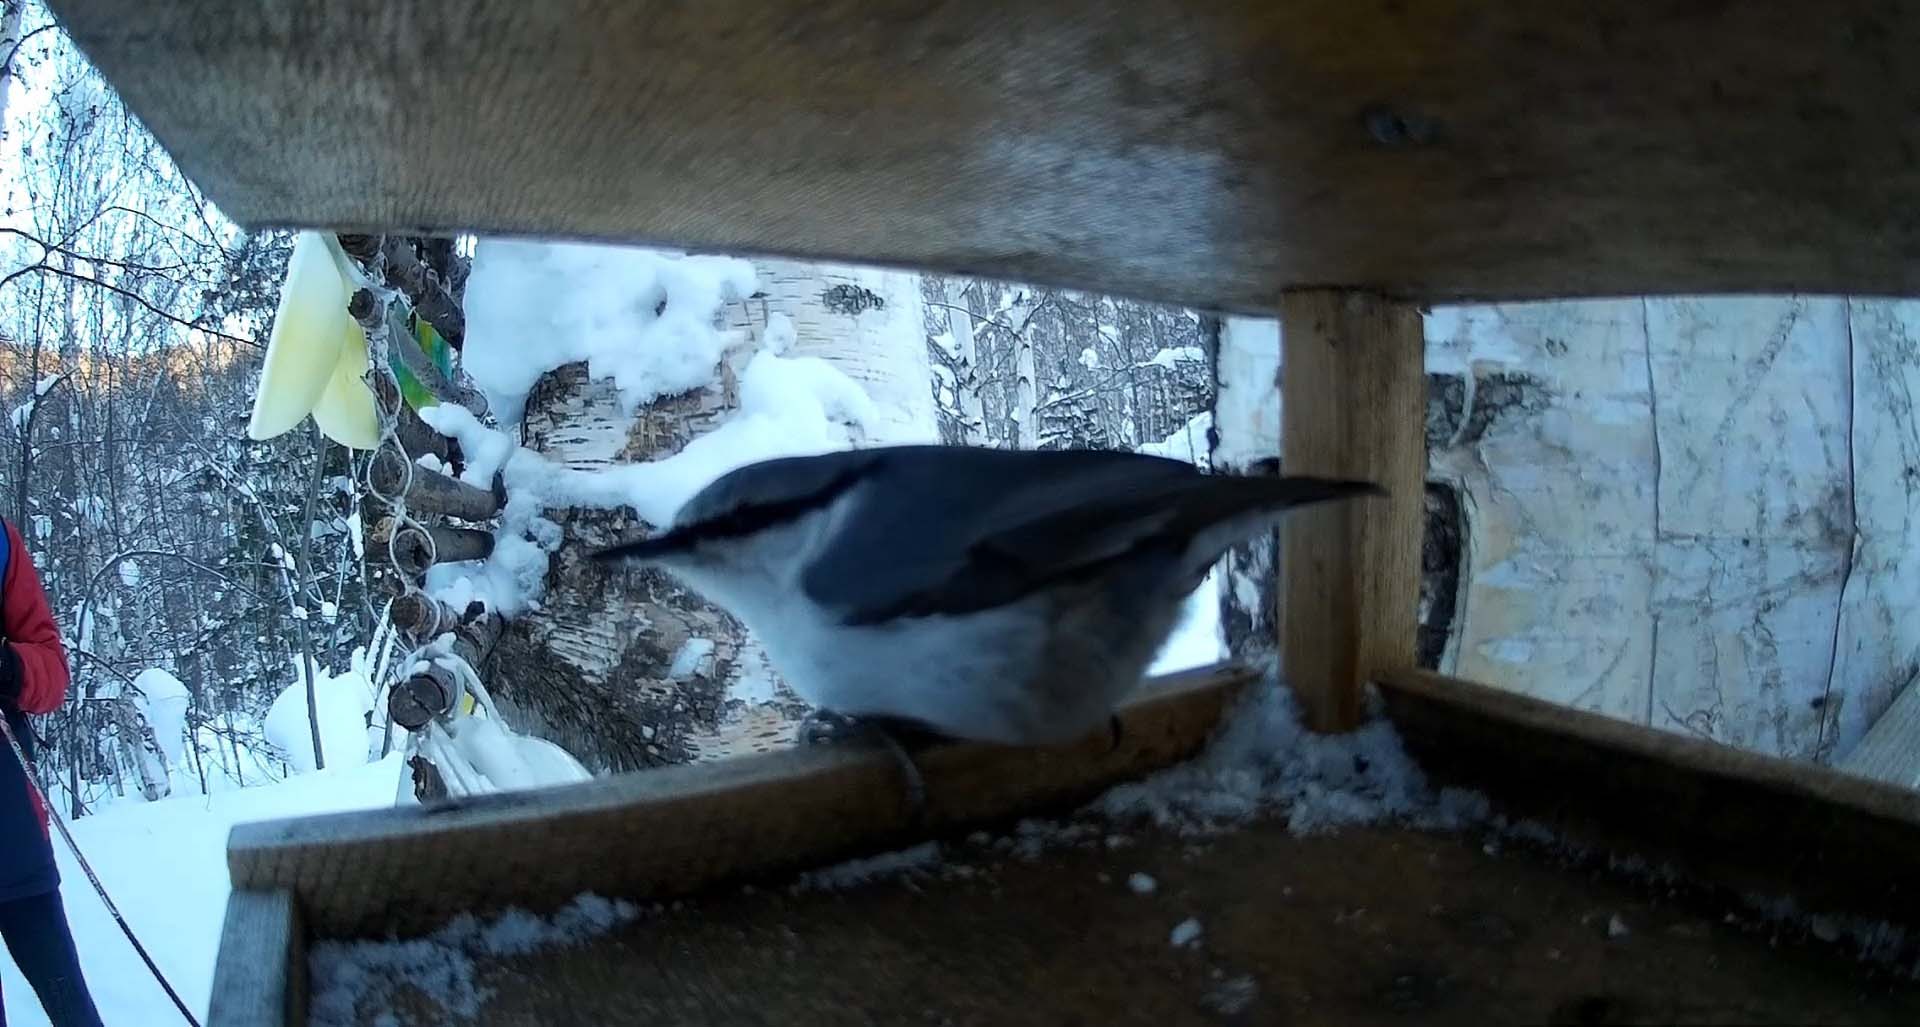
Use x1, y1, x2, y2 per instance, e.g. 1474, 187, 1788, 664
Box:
599, 445, 1380, 624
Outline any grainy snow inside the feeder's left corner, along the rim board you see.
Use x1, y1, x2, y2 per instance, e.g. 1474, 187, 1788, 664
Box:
307, 893, 639, 1027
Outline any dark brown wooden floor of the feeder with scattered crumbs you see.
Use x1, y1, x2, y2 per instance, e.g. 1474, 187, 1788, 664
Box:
362, 822, 1920, 1027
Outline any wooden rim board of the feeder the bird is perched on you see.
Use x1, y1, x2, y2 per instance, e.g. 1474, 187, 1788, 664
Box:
223, 666, 1256, 944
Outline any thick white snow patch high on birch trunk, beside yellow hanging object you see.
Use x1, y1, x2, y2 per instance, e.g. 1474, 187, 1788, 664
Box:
461, 238, 756, 424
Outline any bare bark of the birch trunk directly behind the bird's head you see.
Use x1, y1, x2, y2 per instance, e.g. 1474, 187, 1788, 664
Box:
490, 261, 937, 774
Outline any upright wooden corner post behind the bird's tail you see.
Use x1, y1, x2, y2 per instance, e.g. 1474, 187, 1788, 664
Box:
1279, 290, 1427, 731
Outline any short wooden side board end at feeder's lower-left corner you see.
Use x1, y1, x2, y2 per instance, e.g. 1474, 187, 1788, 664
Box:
209, 889, 307, 1027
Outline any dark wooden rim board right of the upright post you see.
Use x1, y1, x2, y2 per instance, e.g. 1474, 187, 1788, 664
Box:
1377, 672, 1920, 927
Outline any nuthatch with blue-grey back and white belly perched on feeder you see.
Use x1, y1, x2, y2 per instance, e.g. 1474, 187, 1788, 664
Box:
595, 445, 1382, 806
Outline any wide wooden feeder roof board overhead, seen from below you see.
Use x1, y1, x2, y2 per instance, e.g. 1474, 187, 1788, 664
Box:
50, 0, 1920, 311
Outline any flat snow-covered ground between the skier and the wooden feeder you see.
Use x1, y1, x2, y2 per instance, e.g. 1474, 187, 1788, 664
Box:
0, 752, 407, 1027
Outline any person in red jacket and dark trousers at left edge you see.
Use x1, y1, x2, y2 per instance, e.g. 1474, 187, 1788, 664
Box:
0, 520, 100, 1027
